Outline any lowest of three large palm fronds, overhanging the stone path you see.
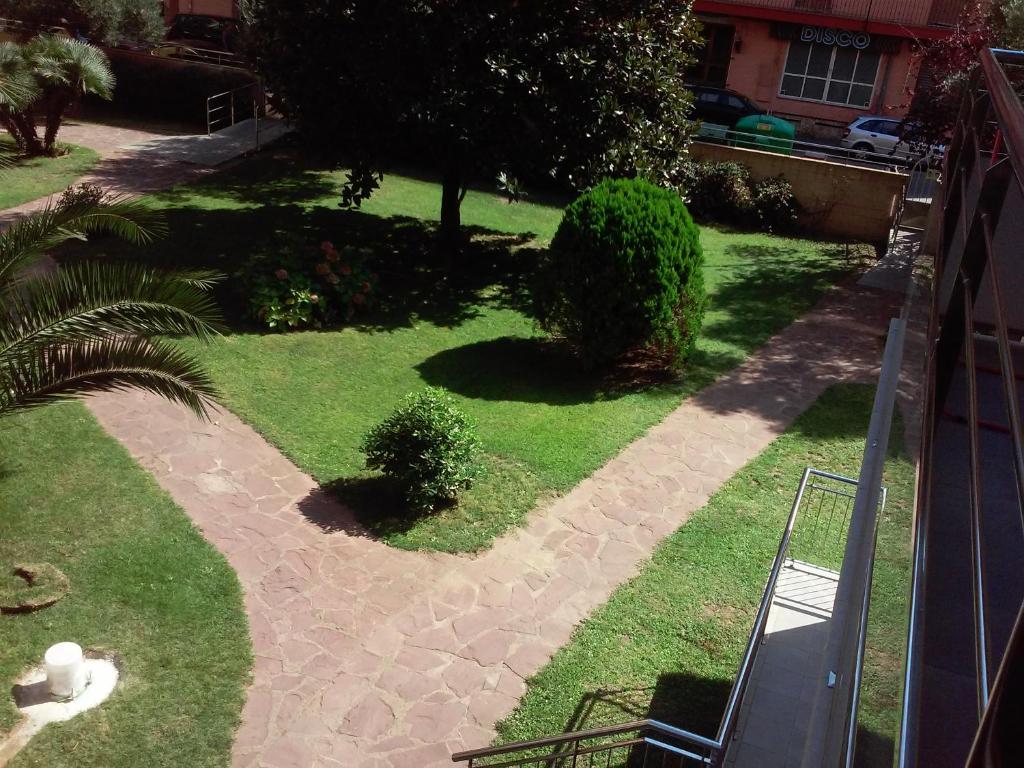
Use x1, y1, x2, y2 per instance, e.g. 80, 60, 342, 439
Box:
0, 337, 216, 418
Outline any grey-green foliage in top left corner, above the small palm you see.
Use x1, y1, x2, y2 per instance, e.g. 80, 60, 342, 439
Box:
0, 0, 165, 45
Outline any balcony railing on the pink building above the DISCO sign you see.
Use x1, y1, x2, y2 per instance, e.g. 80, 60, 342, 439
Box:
697, 0, 964, 27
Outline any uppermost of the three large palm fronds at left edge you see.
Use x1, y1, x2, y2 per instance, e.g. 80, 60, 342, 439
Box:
0, 198, 167, 285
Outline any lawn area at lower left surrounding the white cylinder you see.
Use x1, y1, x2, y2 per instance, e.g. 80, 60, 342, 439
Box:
0, 402, 252, 768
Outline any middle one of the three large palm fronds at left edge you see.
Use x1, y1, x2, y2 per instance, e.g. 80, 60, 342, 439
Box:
0, 262, 222, 362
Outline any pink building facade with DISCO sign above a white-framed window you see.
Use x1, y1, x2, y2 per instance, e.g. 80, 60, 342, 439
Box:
691, 0, 966, 138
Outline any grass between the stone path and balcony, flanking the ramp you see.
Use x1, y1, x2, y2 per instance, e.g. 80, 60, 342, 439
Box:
498, 385, 914, 766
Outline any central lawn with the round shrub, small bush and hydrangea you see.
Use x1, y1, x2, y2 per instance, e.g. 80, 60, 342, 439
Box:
61, 155, 863, 551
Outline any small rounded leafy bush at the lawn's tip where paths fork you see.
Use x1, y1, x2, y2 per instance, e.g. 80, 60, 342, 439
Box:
362, 387, 481, 512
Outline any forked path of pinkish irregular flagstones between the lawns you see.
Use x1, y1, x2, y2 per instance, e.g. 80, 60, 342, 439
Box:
89, 287, 899, 768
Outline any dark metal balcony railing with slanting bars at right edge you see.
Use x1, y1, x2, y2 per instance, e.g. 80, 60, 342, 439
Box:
898, 50, 1024, 768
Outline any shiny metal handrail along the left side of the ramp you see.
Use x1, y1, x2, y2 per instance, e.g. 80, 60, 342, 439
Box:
452, 467, 886, 768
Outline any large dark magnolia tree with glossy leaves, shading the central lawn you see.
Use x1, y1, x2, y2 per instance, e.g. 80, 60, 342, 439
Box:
242, 0, 697, 237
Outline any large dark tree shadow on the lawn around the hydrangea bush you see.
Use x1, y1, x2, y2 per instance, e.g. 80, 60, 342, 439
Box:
56, 199, 538, 333
